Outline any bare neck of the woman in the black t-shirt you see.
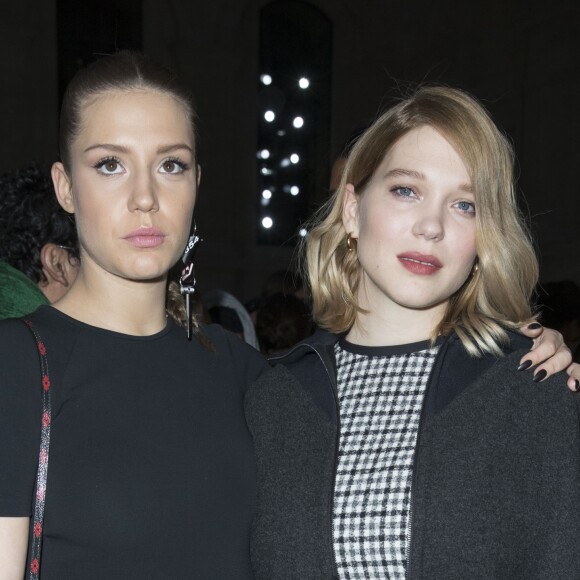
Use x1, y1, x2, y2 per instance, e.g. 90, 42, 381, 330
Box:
53, 269, 167, 336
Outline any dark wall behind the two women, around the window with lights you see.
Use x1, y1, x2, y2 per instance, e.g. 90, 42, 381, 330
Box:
0, 0, 580, 299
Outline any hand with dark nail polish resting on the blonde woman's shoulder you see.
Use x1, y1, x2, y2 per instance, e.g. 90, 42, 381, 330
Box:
518, 324, 580, 388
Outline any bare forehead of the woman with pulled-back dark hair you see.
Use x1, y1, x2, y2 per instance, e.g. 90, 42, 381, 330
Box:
77, 89, 193, 146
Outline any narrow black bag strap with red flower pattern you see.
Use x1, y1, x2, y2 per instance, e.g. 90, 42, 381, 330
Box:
23, 319, 51, 580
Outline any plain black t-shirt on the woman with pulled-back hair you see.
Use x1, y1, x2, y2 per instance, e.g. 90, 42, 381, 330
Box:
0, 306, 267, 580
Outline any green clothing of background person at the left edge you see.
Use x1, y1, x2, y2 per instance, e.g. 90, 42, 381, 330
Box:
0, 261, 48, 319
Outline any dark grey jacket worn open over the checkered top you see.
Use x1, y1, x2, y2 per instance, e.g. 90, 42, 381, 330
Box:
245, 334, 580, 580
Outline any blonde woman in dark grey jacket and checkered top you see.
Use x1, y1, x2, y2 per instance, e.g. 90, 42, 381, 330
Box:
246, 87, 580, 580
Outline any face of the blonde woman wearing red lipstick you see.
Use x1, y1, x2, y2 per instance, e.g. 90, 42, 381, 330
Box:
343, 126, 476, 318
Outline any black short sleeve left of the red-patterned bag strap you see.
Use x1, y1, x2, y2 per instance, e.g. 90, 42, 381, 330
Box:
0, 319, 42, 517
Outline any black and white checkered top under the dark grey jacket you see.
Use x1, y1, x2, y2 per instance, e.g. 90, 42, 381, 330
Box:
333, 341, 438, 580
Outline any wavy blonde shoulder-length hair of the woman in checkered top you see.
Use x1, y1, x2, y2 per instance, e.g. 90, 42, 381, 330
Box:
303, 86, 538, 356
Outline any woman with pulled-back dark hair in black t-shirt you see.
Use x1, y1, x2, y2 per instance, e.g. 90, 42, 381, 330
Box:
0, 53, 266, 580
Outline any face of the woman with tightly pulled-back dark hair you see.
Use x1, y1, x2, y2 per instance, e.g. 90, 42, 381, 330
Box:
53, 90, 197, 281
